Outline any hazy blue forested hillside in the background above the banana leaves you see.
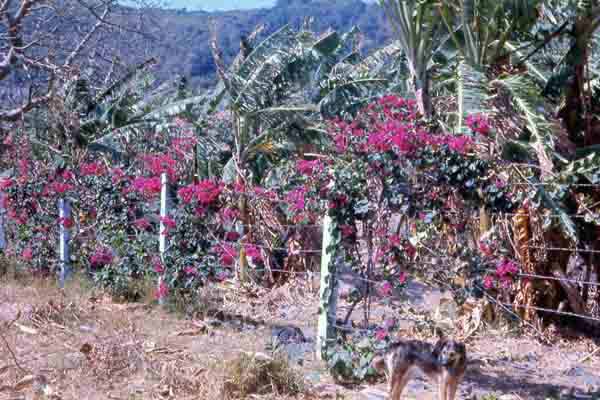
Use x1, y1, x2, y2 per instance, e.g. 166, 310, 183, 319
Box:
155, 0, 392, 85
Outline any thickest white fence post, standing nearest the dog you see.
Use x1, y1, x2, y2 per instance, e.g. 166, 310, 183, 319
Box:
317, 216, 338, 360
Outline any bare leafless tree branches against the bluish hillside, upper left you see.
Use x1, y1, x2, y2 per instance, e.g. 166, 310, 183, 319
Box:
0, 0, 159, 122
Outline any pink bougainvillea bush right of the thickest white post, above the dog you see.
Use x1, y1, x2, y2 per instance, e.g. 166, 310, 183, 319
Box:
285, 96, 514, 314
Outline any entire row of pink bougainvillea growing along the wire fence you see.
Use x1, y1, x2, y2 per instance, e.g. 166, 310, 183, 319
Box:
0, 96, 513, 322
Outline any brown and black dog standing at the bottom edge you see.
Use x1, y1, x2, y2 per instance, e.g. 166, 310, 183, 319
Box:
372, 338, 467, 400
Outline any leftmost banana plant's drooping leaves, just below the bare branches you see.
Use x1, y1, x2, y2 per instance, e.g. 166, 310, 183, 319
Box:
28, 60, 190, 161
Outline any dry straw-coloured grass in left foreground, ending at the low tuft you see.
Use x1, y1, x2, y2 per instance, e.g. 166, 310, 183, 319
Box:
0, 275, 318, 400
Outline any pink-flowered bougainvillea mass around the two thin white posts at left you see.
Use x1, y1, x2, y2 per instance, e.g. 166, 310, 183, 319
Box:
1, 117, 244, 299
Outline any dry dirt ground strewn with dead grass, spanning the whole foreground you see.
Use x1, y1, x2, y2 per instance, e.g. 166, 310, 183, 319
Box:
0, 281, 600, 400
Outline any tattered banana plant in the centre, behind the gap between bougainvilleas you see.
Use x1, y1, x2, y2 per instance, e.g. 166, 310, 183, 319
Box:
211, 21, 396, 279
